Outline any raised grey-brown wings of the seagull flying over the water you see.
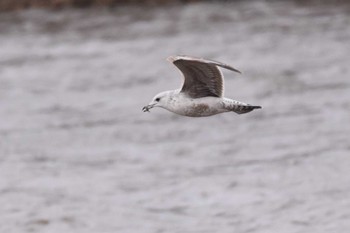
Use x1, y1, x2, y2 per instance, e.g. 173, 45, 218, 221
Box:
167, 56, 240, 98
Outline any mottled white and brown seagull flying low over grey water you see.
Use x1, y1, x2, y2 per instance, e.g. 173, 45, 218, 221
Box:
142, 55, 261, 117
